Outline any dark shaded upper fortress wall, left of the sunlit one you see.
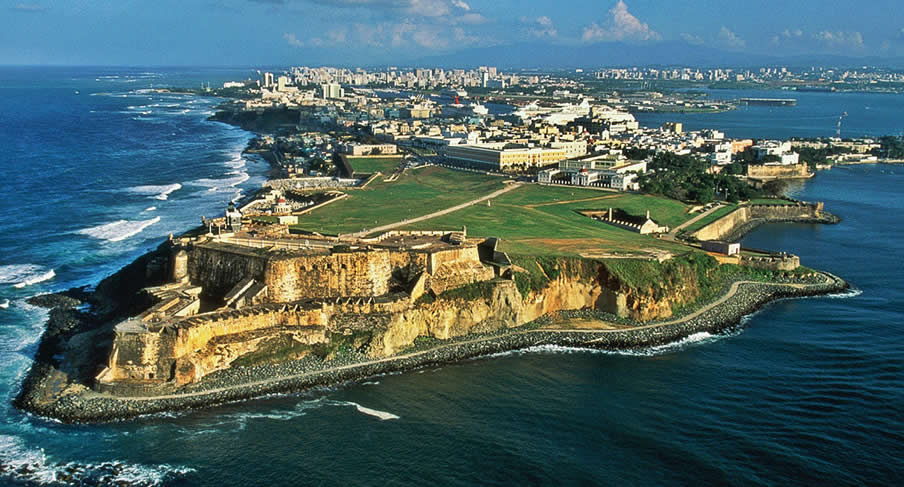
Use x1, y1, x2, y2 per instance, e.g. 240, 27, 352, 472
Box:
188, 244, 268, 296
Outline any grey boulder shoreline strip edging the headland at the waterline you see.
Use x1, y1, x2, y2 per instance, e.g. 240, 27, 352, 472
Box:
16, 274, 848, 423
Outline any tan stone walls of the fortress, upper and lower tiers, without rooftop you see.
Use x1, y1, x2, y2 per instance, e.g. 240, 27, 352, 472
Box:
97, 241, 494, 393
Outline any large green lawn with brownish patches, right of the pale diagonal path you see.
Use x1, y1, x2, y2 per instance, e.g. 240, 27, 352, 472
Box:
398, 185, 689, 256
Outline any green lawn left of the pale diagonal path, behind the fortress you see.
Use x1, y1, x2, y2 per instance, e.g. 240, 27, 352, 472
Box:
293, 167, 503, 234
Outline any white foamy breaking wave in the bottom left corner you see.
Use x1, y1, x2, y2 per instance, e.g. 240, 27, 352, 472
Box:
0, 435, 195, 487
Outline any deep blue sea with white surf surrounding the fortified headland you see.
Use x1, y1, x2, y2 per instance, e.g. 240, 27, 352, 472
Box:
0, 68, 904, 486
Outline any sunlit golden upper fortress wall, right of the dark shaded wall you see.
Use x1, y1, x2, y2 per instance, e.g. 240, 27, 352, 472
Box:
264, 250, 392, 302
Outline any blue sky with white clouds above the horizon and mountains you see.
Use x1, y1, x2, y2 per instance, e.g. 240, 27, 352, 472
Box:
0, 0, 904, 66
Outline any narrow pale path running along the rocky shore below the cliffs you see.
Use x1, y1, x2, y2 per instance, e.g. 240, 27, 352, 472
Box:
96, 278, 828, 401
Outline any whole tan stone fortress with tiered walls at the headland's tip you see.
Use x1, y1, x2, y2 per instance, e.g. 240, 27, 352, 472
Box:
95, 205, 500, 395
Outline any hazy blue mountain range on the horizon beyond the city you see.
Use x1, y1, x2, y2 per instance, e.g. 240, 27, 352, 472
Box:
407, 41, 904, 69
